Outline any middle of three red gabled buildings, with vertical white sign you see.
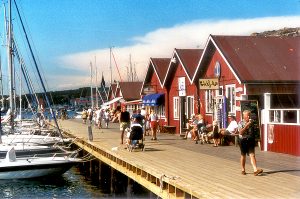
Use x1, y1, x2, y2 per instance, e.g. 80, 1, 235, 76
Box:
163, 49, 203, 133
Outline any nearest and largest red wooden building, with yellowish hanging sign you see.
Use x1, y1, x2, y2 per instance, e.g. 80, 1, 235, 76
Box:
193, 36, 300, 156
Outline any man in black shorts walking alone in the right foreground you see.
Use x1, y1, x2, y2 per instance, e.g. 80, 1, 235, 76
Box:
238, 110, 263, 176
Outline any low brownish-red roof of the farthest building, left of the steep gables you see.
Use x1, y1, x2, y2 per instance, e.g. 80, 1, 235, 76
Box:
119, 82, 143, 101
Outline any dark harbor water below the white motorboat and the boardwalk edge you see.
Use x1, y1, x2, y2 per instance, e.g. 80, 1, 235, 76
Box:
0, 166, 156, 199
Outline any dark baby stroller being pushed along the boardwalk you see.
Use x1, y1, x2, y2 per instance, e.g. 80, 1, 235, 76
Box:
127, 123, 145, 152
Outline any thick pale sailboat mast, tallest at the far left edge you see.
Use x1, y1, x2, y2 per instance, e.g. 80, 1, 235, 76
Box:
7, 0, 15, 131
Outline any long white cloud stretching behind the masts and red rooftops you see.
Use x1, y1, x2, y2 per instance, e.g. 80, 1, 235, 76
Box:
59, 16, 300, 89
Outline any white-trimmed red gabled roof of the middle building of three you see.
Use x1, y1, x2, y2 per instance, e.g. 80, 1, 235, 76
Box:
163, 48, 203, 85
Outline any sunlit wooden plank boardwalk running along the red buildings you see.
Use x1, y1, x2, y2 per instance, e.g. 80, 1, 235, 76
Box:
59, 119, 300, 198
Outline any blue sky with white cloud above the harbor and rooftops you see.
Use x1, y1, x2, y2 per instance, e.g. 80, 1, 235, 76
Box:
0, 0, 300, 90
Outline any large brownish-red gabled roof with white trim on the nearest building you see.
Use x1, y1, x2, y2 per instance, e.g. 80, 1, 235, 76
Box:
193, 36, 300, 83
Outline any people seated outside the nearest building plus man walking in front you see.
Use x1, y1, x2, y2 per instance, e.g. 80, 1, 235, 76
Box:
184, 110, 263, 176
